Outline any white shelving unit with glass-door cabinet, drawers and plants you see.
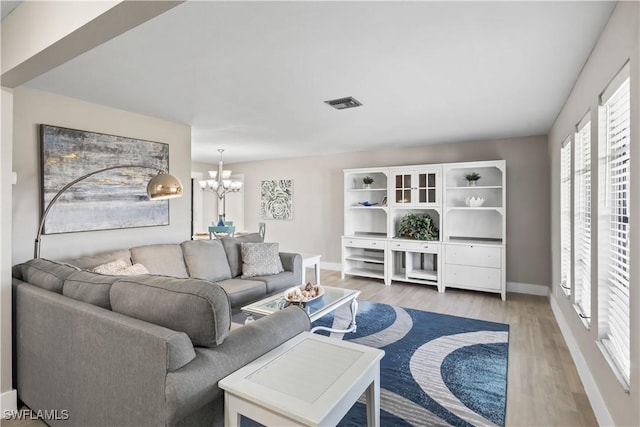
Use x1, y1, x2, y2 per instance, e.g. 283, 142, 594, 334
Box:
342, 160, 506, 299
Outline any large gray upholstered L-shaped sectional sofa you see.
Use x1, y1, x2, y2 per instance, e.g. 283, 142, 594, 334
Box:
13, 236, 310, 426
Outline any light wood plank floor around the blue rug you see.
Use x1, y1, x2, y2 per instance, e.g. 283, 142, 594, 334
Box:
2, 270, 598, 427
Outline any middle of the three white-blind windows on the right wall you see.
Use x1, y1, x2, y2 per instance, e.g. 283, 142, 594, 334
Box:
573, 113, 591, 324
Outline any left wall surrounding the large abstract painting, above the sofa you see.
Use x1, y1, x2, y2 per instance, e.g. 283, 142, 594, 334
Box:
12, 87, 191, 264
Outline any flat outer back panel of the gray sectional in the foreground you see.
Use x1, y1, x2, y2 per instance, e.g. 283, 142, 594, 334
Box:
14, 283, 196, 426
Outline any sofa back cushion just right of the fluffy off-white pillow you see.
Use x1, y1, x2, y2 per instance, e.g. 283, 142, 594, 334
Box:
131, 244, 189, 278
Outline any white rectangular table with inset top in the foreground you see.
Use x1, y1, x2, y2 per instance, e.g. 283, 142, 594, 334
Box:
218, 332, 384, 426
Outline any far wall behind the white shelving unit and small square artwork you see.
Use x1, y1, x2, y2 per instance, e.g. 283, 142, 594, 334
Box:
230, 136, 550, 286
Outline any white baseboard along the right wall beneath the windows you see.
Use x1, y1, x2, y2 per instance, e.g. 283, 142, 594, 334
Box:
549, 295, 615, 426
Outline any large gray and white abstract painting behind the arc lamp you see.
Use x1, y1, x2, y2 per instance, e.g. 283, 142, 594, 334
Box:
40, 125, 169, 234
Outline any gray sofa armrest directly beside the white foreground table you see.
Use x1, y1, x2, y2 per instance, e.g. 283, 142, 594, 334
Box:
167, 306, 311, 423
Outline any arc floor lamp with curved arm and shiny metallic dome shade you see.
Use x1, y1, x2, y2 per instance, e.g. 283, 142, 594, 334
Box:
33, 165, 182, 258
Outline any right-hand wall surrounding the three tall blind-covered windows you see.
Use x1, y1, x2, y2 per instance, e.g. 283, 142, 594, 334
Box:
549, 2, 640, 426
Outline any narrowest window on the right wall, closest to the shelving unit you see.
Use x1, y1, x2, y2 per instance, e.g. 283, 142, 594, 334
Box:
560, 137, 571, 295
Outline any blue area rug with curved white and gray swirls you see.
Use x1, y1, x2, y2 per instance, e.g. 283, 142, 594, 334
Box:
312, 301, 509, 427
